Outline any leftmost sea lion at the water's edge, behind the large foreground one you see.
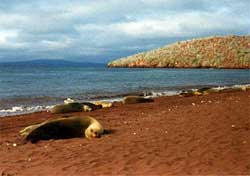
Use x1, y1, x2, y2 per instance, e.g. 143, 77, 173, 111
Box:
50, 102, 83, 114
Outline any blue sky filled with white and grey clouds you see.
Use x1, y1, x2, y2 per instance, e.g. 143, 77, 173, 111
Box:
0, 0, 250, 62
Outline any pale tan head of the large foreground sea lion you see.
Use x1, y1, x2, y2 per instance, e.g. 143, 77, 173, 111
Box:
85, 123, 104, 138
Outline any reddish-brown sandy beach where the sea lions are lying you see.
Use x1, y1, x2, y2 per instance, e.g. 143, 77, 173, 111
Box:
0, 91, 250, 175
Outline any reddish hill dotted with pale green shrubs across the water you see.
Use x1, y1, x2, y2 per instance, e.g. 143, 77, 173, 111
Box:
108, 35, 250, 68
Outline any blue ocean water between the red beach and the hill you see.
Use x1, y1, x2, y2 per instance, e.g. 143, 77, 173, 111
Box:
0, 64, 250, 116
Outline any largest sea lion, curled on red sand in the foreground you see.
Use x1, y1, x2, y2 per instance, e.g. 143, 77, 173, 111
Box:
20, 116, 104, 143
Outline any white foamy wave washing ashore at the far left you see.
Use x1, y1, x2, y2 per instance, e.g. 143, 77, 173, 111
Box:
0, 106, 52, 117
